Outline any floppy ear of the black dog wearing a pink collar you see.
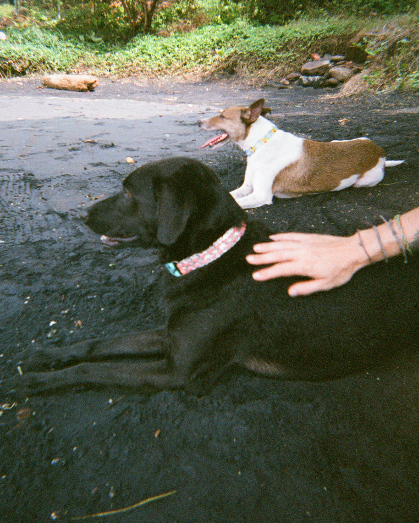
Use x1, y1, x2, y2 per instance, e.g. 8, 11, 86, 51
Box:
154, 178, 195, 245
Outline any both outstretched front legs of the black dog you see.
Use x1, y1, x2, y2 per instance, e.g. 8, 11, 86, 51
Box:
1, 329, 195, 396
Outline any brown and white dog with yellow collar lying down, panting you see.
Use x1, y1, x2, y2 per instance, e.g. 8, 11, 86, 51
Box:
200, 98, 403, 209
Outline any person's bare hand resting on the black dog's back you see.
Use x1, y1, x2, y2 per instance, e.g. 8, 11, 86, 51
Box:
246, 233, 369, 297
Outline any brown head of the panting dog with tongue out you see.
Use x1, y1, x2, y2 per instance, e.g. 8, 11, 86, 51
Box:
200, 98, 271, 149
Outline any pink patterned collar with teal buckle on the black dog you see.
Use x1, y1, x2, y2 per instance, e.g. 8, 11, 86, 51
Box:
165, 222, 246, 276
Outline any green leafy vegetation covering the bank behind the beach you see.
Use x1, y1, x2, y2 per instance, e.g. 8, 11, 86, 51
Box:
0, 0, 419, 89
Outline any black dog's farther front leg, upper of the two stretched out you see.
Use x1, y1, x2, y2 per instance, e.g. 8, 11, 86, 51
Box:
17, 329, 171, 372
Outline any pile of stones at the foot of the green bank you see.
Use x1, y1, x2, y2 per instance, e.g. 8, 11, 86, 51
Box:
279, 55, 362, 87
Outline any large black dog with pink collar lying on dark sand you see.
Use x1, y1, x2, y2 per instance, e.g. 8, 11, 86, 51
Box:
3, 158, 419, 393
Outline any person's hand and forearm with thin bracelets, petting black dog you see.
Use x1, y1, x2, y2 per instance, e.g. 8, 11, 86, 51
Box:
246, 207, 419, 296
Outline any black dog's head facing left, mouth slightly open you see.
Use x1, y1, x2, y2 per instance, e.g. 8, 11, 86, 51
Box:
85, 157, 245, 257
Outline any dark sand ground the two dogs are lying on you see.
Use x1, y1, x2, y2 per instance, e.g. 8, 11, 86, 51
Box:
0, 80, 419, 523
